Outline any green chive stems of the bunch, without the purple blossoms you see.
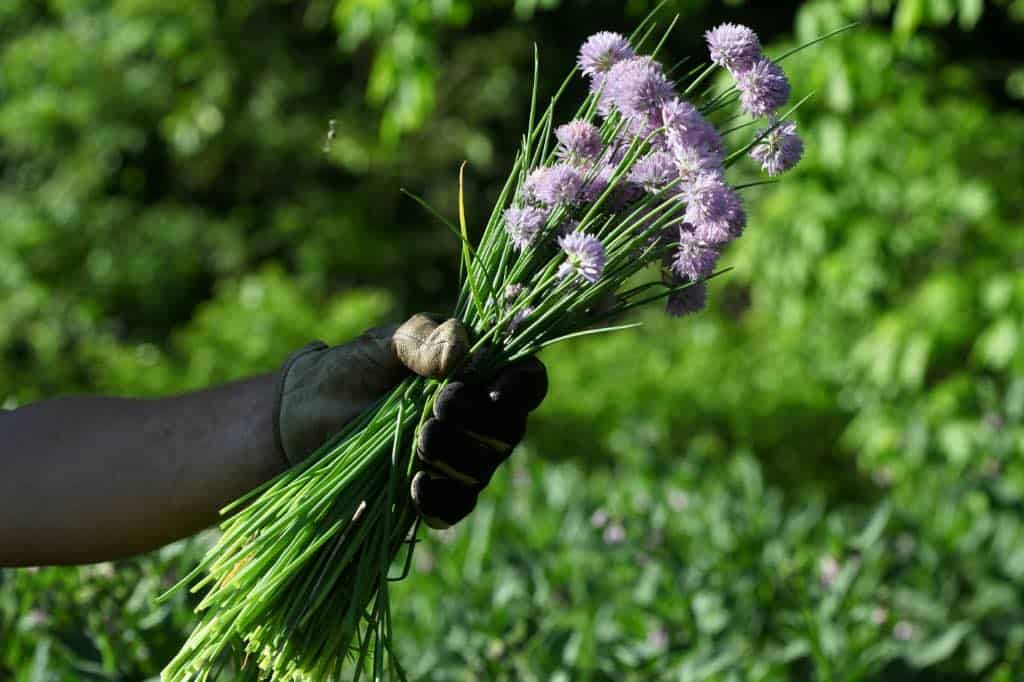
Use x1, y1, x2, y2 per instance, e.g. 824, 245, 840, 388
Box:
163, 13, 847, 682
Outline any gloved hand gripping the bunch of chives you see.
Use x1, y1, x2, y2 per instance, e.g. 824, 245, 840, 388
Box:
274, 314, 547, 527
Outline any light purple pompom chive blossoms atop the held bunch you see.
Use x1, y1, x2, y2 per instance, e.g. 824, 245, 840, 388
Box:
504, 24, 803, 323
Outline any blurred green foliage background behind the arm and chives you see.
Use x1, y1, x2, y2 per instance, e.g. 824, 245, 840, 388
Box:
0, 0, 1024, 682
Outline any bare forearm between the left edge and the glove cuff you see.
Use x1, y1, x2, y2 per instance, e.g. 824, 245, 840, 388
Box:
0, 375, 285, 565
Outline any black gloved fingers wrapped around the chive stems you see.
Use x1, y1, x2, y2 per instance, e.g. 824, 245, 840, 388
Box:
412, 357, 548, 528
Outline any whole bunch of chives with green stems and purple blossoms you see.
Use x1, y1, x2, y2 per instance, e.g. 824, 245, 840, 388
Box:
157, 13, 849, 682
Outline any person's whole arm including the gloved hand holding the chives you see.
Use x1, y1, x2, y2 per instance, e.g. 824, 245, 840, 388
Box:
0, 315, 547, 566
